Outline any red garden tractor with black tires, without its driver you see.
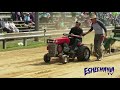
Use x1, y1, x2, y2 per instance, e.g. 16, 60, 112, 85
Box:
44, 34, 90, 64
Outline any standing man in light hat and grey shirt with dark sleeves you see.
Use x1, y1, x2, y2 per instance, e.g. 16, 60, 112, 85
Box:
84, 14, 107, 61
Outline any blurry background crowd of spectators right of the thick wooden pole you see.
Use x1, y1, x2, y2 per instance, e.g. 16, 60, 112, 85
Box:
40, 12, 120, 28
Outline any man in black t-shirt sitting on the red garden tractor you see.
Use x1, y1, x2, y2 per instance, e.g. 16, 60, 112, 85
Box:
69, 21, 83, 53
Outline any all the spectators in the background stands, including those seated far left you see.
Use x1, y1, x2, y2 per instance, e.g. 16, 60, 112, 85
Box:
0, 12, 120, 33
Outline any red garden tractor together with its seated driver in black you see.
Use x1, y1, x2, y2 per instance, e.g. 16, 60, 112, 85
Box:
44, 22, 90, 64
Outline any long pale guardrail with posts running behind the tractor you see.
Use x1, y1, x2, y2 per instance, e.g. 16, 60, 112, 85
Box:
0, 28, 113, 49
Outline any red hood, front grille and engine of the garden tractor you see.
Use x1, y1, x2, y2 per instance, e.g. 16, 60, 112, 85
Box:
47, 37, 70, 57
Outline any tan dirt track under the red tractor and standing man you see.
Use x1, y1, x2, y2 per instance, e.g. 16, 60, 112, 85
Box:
0, 47, 120, 78
